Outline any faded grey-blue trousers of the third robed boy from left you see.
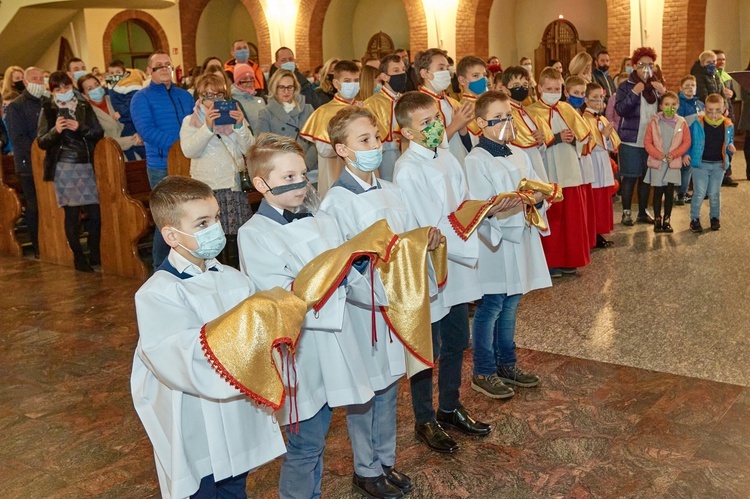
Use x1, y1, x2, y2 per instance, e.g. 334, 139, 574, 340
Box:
346, 383, 398, 477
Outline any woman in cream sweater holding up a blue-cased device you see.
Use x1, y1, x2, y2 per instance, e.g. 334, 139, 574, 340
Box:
180, 73, 254, 268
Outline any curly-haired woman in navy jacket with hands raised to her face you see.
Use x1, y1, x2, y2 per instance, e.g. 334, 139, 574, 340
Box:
615, 47, 664, 225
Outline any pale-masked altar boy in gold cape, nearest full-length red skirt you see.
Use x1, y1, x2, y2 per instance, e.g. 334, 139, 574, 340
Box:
526, 67, 592, 277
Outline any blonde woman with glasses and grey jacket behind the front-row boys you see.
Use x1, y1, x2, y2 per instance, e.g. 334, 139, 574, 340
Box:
256, 69, 318, 171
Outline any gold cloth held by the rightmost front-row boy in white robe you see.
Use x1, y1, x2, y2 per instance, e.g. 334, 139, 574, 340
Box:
448, 178, 563, 241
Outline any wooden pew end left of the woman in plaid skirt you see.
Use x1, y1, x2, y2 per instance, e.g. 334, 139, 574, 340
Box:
31, 141, 73, 267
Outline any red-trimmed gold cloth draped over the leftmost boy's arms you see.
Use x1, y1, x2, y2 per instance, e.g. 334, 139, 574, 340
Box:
201, 288, 307, 410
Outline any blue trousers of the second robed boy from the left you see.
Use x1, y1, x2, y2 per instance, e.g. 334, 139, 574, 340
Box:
279, 404, 333, 499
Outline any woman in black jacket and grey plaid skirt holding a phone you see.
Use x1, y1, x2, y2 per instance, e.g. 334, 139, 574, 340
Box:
37, 71, 104, 272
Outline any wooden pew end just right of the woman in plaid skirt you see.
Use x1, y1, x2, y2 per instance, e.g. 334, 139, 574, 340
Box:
94, 138, 151, 280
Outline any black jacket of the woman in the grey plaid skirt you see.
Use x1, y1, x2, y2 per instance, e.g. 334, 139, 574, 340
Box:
37, 99, 104, 181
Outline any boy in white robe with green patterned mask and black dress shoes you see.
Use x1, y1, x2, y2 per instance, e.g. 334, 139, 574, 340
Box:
395, 90, 513, 453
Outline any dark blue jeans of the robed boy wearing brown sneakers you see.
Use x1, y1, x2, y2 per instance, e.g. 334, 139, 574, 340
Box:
472, 294, 523, 376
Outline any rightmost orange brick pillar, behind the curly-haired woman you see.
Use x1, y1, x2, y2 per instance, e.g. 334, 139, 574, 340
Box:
656, 0, 706, 88
